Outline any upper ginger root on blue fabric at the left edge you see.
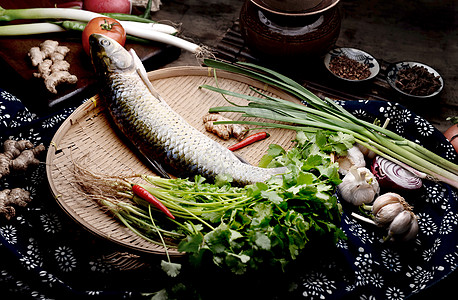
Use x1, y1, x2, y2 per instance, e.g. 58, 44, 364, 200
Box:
0, 140, 45, 178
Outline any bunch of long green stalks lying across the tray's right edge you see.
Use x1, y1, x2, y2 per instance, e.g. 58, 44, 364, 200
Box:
202, 59, 458, 188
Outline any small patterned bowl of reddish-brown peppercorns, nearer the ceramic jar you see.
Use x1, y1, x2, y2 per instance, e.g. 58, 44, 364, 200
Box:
324, 48, 380, 82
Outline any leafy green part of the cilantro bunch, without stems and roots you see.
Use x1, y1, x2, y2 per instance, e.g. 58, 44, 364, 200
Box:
178, 131, 354, 274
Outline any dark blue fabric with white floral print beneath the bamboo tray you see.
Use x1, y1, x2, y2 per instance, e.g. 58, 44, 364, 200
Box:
0, 89, 458, 300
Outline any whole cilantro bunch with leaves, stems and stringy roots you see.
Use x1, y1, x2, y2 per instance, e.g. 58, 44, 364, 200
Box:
90, 130, 354, 277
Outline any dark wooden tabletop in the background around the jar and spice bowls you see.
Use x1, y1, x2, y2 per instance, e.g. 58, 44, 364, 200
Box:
153, 0, 458, 132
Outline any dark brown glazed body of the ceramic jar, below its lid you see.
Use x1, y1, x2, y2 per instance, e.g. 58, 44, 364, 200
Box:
239, 0, 341, 60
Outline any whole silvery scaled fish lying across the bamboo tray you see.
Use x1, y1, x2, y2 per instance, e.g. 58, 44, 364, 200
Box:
91, 35, 284, 184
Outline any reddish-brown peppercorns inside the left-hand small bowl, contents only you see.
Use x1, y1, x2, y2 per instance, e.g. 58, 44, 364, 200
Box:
329, 55, 371, 80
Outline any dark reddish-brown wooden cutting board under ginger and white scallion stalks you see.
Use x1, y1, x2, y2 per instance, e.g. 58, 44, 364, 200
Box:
0, 0, 180, 114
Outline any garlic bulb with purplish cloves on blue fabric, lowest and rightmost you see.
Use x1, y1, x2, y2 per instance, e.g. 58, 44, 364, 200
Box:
372, 193, 418, 241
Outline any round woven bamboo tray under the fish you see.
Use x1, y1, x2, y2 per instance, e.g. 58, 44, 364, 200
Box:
46, 67, 295, 256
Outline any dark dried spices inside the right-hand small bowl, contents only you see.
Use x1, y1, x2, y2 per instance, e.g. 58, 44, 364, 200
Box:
395, 65, 442, 96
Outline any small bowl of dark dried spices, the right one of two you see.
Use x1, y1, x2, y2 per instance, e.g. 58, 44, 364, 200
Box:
386, 61, 444, 99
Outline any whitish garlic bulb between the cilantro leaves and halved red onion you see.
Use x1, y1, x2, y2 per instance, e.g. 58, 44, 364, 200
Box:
338, 167, 380, 206
